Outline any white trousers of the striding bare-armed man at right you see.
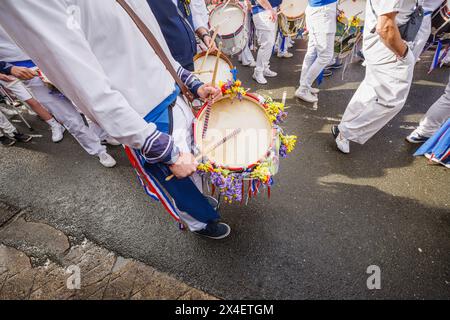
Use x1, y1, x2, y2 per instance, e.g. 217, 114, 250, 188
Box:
339, 51, 415, 144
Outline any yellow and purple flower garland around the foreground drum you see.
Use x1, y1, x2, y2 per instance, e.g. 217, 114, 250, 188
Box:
198, 80, 297, 203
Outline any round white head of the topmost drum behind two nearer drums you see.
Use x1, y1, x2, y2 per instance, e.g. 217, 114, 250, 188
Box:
209, 4, 245, 36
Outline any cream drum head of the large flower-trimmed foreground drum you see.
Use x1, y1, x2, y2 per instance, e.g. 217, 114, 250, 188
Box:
195, 97, 274, 171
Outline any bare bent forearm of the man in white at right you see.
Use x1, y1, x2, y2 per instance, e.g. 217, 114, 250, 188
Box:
376, 12, 408, 58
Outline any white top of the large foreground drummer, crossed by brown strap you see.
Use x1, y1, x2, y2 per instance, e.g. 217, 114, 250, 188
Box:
0, 0, 183, 148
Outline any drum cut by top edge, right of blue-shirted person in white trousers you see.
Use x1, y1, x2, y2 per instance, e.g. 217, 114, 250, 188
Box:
278, 0, 308, 37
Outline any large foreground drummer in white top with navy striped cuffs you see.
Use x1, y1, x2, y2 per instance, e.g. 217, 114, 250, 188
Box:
0, 0, 231, 239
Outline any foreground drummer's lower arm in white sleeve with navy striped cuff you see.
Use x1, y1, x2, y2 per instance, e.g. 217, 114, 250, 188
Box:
0, 0, 173, 162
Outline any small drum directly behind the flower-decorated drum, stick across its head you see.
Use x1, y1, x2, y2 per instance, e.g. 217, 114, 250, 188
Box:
194, 52, 234, 84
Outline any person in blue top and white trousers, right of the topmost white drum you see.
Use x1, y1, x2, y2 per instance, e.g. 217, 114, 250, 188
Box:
252, 0, 282, 84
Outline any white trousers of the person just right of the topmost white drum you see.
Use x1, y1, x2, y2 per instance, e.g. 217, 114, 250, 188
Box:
253, 8, 278, 72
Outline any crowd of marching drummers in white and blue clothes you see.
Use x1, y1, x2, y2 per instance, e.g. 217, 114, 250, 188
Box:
0, 0, 450, 239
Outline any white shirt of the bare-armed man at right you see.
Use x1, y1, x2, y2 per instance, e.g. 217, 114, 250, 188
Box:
363, 0, 416, 64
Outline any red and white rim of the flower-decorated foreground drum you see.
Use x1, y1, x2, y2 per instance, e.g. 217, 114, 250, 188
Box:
193, 93, 277, 172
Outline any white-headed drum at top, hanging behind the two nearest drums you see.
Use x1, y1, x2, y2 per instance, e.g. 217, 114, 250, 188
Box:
209, 3, 248, 56
